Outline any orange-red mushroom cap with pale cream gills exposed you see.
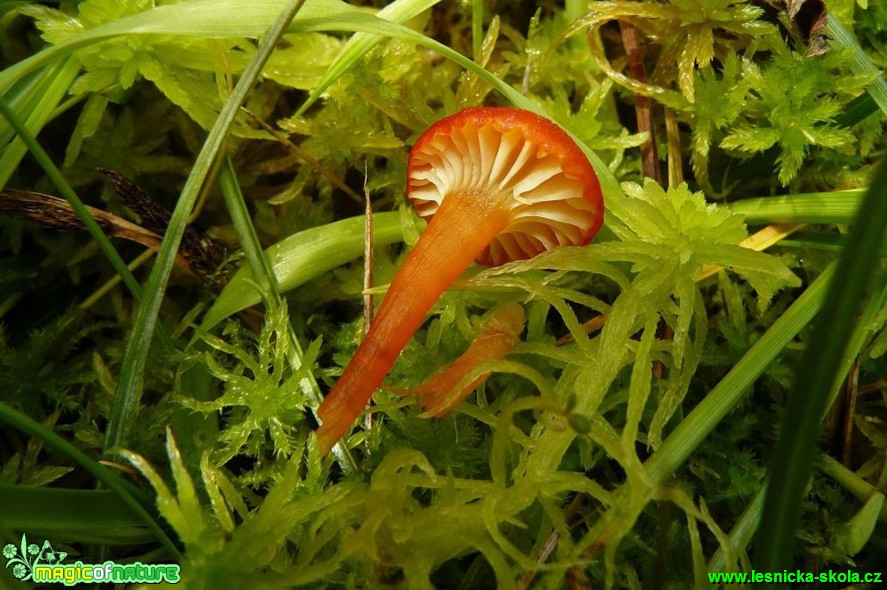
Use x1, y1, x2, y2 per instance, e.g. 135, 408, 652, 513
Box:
407, 107, 604, 266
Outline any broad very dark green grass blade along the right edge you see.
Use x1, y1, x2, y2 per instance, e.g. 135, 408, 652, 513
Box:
756, 160, 887, 571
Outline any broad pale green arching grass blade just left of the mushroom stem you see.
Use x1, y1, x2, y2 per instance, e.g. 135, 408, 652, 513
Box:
201, 212, 403, 330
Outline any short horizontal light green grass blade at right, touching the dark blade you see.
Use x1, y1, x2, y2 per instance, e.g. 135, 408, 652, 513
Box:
729, 189, 865, 225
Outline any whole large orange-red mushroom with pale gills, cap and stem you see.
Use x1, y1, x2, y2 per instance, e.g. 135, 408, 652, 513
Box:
317, 107, 603, 454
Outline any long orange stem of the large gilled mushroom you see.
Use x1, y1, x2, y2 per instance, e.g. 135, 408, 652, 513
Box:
317, 193, 510, 454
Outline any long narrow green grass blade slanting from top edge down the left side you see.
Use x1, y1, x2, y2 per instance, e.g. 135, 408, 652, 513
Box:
104, 0, 304, 451
